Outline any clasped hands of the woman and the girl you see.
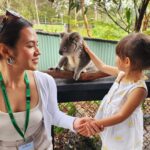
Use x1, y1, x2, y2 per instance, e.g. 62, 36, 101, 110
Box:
73, 117, 104, 137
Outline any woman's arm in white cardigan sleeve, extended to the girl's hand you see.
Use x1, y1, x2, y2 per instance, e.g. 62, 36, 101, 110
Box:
48, 74, 103, 134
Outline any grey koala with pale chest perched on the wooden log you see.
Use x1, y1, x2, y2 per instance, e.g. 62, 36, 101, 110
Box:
56, 32, 96, 80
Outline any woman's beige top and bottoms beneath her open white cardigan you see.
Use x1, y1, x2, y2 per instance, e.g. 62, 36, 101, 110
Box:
0, 96, 53, 150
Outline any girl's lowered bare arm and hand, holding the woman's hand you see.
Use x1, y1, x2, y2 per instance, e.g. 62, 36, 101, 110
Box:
78, 88, 147, 136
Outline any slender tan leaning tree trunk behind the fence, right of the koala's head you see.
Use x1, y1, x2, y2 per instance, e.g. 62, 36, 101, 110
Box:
81, 0, 91, 37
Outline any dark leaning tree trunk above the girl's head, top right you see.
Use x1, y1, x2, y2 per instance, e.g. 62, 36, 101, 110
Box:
134, 0, 150, 32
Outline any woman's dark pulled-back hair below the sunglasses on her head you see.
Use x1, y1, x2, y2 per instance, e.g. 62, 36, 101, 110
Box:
0, 18, 32, 48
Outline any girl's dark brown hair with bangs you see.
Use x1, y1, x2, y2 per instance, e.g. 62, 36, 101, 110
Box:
116, 33, 150, 70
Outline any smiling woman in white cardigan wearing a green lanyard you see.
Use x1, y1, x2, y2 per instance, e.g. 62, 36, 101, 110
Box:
0, 11, 99, 150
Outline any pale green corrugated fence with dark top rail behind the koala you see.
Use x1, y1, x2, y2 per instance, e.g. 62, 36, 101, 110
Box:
37, 32, 117, 70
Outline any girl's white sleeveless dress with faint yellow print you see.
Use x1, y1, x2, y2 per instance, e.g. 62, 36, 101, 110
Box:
95, 74, 147, 150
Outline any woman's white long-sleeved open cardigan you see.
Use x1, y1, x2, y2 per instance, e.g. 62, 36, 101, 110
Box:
34, 71, 75, 139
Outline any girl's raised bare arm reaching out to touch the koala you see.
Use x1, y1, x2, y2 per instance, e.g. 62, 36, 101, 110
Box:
83, 43, 119, 76
